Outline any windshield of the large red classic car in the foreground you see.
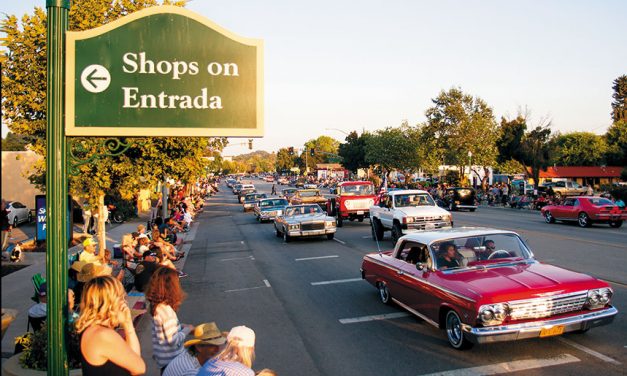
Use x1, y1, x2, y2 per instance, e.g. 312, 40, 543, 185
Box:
430, 233, 532, 270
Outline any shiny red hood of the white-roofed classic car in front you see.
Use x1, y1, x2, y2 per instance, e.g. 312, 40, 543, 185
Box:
443, 261, 608, 304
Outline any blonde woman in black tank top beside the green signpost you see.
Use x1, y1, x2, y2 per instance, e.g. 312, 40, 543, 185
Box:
76, 276, 146, 376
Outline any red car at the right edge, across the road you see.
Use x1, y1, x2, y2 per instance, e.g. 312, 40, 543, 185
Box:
541, 196, 627, 228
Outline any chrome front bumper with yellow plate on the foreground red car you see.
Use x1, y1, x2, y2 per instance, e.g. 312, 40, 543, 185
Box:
462, 307, 618, 344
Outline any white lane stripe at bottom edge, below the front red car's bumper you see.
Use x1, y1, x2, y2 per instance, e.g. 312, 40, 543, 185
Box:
422, 354, 581, 376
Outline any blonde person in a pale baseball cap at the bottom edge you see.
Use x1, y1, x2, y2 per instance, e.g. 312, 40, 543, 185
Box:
197, 326, 255, 376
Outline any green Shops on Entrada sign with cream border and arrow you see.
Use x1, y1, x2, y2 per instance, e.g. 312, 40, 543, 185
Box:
65, 6, 263, 137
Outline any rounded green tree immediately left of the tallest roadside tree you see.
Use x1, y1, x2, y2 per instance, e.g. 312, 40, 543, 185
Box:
365, 122, 420, 182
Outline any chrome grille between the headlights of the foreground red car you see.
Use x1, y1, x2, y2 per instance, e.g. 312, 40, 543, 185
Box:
508, 291, 588, 320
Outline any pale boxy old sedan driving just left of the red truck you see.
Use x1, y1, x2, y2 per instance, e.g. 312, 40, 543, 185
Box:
274, 204, 337, 243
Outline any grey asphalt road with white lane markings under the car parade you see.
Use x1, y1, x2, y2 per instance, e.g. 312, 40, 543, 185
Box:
179, 180, 627, 375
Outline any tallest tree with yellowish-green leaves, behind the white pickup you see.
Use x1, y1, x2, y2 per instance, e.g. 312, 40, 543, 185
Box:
422, 88, 500, 185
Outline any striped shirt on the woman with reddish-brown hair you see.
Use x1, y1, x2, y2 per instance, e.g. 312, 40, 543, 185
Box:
152, 303, 189, 368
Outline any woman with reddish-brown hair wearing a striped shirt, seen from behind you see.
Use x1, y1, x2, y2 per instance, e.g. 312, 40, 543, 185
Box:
146, 267, 194, 373
